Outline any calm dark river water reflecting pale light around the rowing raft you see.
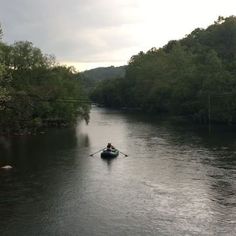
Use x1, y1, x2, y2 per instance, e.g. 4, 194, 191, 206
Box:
0, 107, 236, 236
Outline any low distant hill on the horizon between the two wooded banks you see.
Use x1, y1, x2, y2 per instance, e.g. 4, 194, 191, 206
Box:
80, 66, 126, 81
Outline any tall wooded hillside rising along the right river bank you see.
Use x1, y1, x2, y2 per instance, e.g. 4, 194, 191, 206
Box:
91, 16, 236, 123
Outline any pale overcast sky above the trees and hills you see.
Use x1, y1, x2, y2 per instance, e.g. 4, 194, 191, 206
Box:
0, 0, 236, 71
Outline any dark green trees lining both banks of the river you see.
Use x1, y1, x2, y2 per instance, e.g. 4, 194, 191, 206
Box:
0, 16, 236, 135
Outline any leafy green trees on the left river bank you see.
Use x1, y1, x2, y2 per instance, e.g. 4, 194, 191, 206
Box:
0, 27, 90, 135
